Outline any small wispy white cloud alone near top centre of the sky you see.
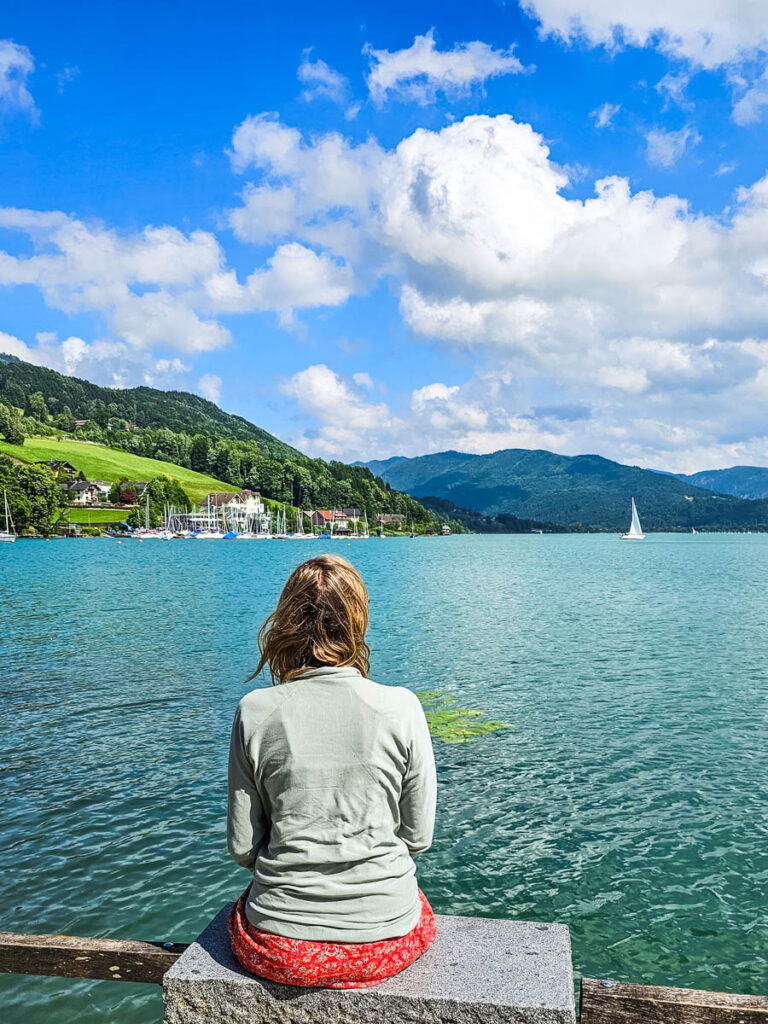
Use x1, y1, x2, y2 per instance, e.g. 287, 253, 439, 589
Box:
364, 29, 526, 104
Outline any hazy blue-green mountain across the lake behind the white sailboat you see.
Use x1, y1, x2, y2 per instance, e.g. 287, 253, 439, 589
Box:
367, 449, 768, 530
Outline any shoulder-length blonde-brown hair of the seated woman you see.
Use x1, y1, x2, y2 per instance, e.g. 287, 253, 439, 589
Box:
249, 555, 371, 683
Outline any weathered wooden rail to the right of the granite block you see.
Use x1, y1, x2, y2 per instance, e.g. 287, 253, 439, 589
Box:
581, 978, 768, 1024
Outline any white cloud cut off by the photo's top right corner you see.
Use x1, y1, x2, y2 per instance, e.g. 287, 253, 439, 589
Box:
522, 0, 768, 69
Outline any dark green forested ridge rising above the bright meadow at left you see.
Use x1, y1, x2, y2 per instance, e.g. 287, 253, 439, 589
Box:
0, 353, 299, 459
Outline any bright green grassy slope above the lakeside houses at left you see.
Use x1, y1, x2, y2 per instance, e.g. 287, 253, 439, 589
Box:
0, 437, 233, 503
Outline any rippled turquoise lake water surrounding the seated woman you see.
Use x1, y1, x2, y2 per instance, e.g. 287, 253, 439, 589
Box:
0, 535, 768, 1024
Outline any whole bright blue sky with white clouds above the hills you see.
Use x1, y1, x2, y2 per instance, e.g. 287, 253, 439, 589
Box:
0, 0, 768, 471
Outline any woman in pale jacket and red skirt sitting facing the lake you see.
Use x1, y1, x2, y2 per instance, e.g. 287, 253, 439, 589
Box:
227, 555, 436, 988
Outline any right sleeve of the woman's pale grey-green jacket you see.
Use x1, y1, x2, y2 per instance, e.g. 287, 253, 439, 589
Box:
397, 694, 437, 857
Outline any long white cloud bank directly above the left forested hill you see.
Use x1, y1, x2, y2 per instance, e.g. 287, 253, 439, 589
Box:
0, 202, 354, 353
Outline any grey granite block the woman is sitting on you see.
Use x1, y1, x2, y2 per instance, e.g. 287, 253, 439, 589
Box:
163, 906, 575, 1024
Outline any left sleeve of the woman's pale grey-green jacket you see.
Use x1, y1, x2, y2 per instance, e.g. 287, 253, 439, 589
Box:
226, 707, 266, 868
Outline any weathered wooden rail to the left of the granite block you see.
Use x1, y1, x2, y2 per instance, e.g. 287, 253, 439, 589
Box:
0, 932, 186, 985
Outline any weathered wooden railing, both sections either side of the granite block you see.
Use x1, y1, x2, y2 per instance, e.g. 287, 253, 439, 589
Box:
0, 932, 768, 1024
